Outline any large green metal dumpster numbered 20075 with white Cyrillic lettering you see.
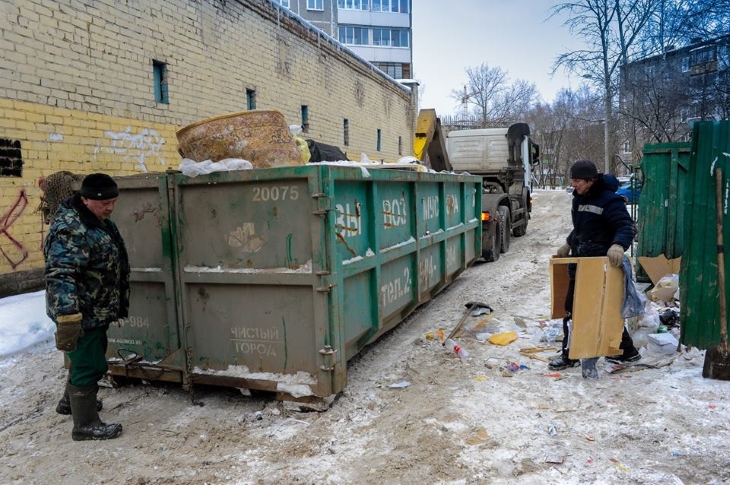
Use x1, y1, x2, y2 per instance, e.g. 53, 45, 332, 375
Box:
107, 165, 481, 407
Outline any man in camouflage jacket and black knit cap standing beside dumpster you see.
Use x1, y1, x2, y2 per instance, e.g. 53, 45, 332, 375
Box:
43, 173, 130, 441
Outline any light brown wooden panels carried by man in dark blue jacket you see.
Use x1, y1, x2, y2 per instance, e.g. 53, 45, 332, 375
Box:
550, 257, 624, 359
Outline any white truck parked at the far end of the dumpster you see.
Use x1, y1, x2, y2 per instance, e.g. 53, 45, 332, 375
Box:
446, 123, 540, 262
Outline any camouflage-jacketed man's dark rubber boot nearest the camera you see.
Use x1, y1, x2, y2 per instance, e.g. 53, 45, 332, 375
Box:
68, 384, 122, 441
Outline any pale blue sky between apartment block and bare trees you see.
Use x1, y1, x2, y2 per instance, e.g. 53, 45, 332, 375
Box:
412, 0, 582, 115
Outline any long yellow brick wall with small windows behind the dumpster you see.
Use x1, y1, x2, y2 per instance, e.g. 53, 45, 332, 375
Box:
0, 0, 414, 276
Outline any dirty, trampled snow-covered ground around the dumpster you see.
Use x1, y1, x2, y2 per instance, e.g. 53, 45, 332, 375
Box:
0, 191, 730, 485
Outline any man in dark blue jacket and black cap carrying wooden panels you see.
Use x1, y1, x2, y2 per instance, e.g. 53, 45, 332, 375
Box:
549, 160, 641, 370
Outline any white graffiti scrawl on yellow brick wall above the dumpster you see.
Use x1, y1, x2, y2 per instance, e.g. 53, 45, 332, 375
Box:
94, 126, 165, 172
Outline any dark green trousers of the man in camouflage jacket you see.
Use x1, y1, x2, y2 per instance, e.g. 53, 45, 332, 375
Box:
66, 328, 109, 387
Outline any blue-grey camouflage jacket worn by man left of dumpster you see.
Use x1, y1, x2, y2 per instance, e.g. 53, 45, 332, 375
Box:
43, 194, 129, 328
